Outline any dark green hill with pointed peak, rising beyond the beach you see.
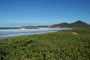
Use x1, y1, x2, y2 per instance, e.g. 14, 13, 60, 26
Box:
51, 20, 90, 28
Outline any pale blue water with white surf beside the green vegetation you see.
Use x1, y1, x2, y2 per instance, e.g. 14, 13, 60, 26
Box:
0, 28, 62, 38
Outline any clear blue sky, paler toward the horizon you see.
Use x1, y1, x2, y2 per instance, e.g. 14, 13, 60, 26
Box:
0, 0, 90, 27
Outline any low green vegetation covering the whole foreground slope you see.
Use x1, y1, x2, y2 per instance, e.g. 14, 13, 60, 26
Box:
0, 28, 90, 60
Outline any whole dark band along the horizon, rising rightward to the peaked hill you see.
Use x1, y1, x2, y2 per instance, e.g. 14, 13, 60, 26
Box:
0, 20, 90, 29
